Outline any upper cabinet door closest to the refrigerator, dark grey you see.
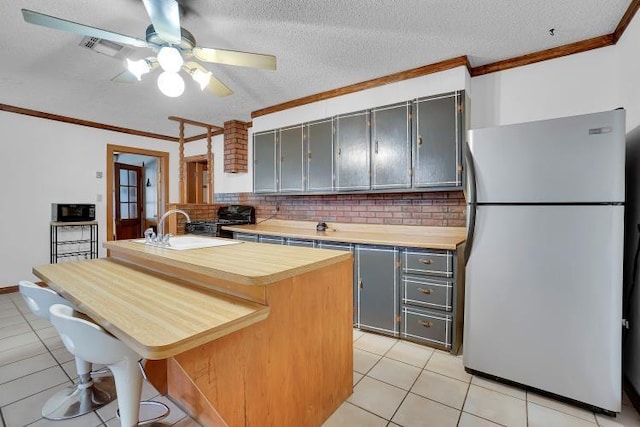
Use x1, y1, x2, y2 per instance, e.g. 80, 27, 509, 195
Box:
413, 92, 462, 187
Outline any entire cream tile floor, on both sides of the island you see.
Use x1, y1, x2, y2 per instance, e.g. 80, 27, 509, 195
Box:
0, 293, 640, 427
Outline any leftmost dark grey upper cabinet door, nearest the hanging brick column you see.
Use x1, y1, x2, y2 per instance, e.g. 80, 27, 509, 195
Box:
253, 131, 278, 193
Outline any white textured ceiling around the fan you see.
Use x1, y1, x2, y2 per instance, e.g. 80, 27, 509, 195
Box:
0, 0, 631, 136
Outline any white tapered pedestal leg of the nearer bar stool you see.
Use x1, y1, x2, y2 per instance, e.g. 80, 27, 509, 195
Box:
109, 359, 142, 427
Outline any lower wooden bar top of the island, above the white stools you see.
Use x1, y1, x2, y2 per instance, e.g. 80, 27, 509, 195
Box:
33, 258, 269, 359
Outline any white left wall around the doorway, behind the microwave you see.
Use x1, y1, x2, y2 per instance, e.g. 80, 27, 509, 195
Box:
0, 112, 178, 287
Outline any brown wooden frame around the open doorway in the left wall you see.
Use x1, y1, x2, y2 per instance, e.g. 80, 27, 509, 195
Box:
105, 144, 169, 241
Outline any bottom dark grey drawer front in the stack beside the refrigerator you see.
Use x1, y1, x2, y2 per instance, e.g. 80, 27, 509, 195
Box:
401, 307, 453, 349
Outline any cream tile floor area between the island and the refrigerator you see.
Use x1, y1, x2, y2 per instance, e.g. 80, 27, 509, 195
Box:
323, 330, 640, 427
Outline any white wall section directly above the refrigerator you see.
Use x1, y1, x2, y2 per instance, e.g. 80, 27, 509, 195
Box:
471, 46, 623, 129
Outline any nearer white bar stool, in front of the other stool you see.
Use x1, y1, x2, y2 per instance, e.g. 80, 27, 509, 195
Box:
49, 304, 169, 427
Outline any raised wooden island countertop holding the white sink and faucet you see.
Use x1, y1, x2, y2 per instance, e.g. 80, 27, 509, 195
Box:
104, 239, 352, 286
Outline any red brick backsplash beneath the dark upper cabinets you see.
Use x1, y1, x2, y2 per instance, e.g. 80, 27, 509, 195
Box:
214, 191, 466, 227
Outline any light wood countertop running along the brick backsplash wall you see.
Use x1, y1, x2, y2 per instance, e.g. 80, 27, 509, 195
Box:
223, 219, 467, 250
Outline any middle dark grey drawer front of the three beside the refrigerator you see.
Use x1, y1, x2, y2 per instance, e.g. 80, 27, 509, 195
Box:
402, 275, 453, 311
